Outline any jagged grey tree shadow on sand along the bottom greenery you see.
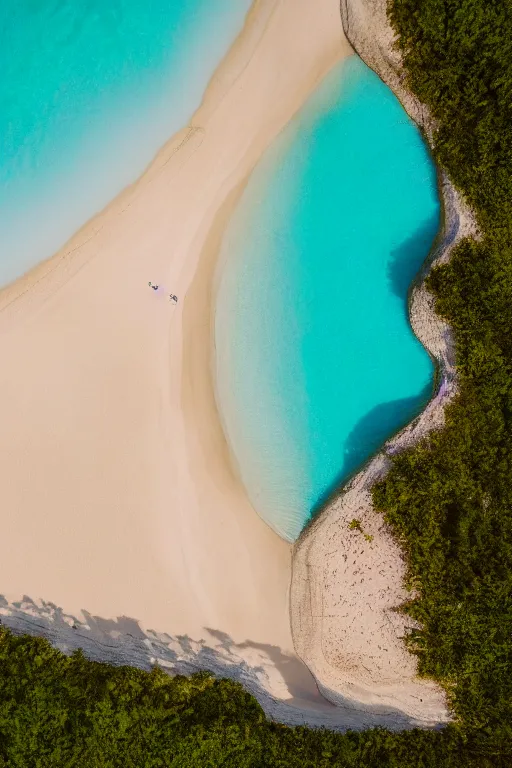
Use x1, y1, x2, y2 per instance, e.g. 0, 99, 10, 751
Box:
0, 595, 436, 730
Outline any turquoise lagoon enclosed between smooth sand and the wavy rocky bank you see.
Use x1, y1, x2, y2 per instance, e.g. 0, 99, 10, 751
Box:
215, 56, 440, 540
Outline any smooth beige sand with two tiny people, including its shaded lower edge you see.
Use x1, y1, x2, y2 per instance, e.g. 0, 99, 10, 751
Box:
0, 0, 368, 727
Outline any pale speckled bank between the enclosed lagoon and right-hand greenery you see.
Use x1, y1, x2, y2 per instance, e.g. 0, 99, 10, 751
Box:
290, 0, 478, 727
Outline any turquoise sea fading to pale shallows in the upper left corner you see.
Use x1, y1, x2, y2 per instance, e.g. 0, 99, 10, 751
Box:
0, 0, 251, 283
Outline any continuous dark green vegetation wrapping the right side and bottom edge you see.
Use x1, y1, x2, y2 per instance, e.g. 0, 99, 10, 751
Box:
0, 0, 512, 768
